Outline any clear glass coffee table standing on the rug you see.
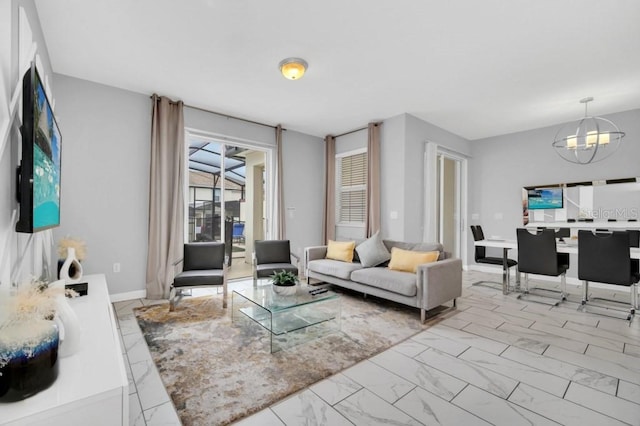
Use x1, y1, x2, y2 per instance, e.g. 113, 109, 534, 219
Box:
231, 284, 342, 353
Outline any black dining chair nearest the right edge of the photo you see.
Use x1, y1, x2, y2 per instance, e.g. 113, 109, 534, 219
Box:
578, 230, 640, 320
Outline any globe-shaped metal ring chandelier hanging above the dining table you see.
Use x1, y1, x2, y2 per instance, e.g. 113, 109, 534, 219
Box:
553, 97, 624, 164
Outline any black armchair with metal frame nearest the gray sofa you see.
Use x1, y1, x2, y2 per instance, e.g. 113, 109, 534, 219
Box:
253, 240, 299, 287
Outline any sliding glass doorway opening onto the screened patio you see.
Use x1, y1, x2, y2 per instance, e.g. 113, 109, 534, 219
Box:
185, 132, 268, 279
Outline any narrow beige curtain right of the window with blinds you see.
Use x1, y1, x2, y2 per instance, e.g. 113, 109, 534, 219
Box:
366, 123, 380, 237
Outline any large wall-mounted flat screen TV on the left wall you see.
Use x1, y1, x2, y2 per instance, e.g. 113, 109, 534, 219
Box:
16, 63, 61, 233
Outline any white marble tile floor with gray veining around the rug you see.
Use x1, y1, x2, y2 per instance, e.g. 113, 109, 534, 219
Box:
114, 271, 640, 426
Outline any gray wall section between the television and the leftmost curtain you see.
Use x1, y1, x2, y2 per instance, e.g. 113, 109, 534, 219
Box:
54, 74, 151, 294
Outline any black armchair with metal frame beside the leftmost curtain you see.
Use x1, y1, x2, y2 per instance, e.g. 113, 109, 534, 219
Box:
169, 242, 227, 312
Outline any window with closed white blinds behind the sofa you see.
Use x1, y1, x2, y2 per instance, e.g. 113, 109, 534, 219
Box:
338, 152, 367, 224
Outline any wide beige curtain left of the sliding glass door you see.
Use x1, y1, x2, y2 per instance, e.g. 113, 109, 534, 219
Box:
147, 94, 185, 299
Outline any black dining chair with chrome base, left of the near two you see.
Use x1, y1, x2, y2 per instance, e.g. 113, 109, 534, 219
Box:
516, 228, 569, 305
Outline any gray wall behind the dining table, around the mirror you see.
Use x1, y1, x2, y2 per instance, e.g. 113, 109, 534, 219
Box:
467, 110, 640, 275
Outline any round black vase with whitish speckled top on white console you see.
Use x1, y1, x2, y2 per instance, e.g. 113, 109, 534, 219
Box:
0, 320, 59, 402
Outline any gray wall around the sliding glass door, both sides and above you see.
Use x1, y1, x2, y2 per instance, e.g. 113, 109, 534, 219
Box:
54, 75, 324, 294
